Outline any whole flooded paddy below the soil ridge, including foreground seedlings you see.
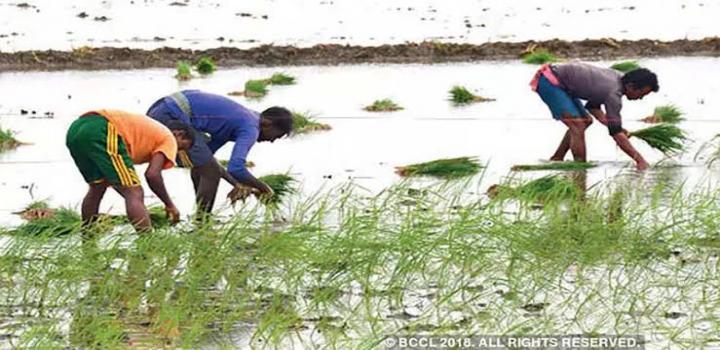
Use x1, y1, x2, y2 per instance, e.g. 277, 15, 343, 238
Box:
0, 57, 720, 348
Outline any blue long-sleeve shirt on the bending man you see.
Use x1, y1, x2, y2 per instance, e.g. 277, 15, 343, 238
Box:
151, 90, 260, 181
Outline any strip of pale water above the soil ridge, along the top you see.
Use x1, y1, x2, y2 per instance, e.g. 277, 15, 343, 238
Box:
0, 0, 720, 51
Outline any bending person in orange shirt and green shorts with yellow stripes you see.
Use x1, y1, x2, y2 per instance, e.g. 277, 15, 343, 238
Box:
66, 109, 193, 231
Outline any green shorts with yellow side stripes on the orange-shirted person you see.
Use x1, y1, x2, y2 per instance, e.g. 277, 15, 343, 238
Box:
66, 114, 140, 187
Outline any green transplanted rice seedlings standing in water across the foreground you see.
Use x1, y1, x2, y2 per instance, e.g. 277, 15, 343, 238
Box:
5, 177, 720, 349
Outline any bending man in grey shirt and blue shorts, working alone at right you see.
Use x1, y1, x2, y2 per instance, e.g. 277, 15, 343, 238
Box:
530, 62, 659, 170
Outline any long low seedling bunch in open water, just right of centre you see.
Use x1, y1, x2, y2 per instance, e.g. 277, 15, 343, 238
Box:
395, 157, 482, 179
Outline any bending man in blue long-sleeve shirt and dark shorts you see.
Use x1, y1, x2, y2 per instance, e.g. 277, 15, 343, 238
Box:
147, 90, 293, 213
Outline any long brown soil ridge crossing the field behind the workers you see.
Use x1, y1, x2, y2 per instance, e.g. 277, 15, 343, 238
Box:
0, 37, 720, 71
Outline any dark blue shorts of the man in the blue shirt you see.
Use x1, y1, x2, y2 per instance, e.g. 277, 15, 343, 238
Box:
147, 99, 215, 168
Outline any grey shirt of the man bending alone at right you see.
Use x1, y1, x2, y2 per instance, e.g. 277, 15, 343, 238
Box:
554, 62, 624, 130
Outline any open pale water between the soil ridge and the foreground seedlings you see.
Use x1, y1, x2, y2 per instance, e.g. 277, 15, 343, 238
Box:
0, 58, 720, 225
